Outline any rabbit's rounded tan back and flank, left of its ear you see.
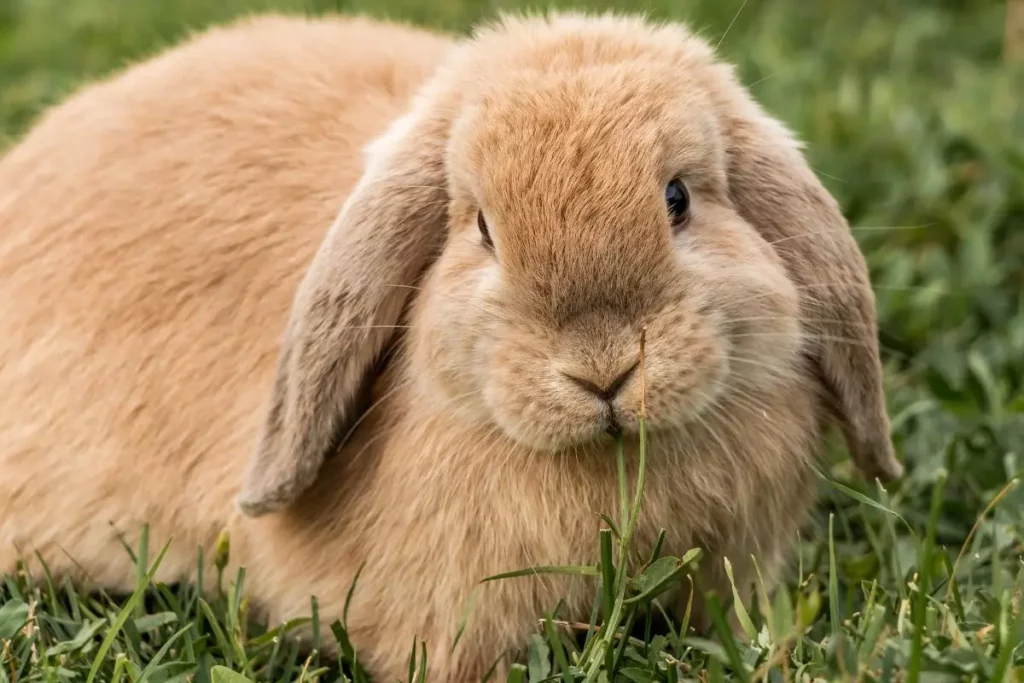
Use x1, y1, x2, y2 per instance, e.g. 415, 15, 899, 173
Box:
0, 16, 447, 586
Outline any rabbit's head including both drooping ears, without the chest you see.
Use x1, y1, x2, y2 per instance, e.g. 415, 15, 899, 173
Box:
240, 14, 900, 515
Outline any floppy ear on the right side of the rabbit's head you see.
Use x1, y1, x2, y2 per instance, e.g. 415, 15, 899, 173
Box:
727, 97, 903, 482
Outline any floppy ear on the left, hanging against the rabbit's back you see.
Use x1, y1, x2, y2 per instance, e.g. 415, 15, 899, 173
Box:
238, 100, 447, 516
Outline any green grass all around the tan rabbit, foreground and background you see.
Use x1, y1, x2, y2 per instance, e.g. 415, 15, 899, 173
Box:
0, 0, 1024, 683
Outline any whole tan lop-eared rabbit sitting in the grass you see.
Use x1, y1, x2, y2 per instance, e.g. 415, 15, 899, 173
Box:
0, 11, 902, 681
